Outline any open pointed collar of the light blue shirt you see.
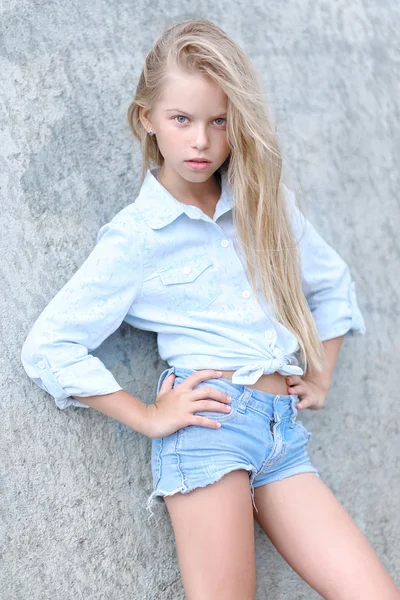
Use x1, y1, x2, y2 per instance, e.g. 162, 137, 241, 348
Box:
134, 167, 232, 229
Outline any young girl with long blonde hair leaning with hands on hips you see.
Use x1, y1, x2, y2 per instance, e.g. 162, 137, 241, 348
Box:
21, 20, 400, 600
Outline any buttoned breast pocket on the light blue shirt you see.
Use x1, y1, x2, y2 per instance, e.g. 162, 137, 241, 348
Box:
156, 254, 221, 312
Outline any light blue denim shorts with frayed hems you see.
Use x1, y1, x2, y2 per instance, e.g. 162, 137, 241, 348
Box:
147, 367, 319, 515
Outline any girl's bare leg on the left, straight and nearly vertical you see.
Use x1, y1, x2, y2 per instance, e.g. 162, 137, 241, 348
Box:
164, 469, 255, 600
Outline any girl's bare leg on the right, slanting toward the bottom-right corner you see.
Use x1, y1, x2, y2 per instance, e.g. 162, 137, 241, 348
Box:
254, 473, 400, 600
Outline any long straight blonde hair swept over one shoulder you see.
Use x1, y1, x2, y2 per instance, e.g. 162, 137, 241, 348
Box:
128, 19, 327, 372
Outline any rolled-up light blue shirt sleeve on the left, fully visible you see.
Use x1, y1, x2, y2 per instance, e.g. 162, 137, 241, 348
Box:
21, 219, 143, 409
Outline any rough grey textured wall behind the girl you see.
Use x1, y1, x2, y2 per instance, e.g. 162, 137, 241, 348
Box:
0, 0, 400, 600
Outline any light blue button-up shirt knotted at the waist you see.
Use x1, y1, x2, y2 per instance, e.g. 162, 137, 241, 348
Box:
21, 169, 366, 409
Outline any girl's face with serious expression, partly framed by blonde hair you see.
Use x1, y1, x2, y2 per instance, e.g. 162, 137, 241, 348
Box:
141, 71, 230, 188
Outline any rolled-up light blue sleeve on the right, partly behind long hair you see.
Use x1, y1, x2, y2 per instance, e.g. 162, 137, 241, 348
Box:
285, 186, 366, 341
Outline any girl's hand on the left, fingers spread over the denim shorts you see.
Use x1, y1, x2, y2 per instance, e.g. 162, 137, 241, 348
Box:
146, 369, 231, 438
